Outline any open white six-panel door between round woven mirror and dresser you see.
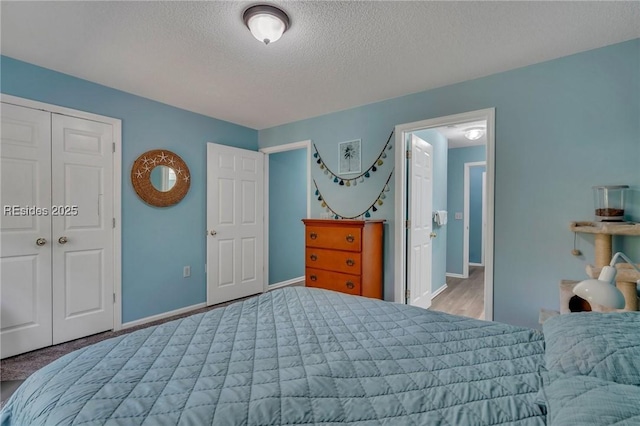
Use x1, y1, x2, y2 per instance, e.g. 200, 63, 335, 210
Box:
207, 143, 264, 305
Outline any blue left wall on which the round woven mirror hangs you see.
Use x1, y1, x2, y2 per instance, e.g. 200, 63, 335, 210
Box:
0, 56, 258, 322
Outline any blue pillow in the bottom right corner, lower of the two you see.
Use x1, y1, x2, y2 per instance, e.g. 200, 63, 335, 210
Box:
539, 372, 640, 426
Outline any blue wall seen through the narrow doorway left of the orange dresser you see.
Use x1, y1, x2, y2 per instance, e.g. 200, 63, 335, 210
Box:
269, 149, 308, 284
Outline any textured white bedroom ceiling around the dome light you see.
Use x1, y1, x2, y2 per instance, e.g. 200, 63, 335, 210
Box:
0, 1, 640, 129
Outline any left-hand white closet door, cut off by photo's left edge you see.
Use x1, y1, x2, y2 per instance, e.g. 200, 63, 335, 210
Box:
0, 103, 52, 358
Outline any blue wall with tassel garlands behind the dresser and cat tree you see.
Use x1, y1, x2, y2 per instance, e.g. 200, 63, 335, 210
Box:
259, 39, 640, 327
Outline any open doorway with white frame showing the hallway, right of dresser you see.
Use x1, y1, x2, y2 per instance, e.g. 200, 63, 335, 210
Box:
394, 109, 495, 320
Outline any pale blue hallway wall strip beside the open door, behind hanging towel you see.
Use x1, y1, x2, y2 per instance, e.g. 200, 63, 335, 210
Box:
415, 130, 449, 294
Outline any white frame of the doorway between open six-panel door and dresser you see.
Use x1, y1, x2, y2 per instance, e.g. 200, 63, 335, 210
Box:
260, 139, 311, 291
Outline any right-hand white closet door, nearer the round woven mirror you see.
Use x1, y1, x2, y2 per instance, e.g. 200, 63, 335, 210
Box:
51, 114, 114, 344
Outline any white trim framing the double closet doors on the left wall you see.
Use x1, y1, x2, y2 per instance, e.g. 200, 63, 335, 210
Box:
0, 94, 122, 331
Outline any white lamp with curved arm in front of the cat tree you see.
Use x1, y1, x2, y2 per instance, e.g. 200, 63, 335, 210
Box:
573, 252, 640, 309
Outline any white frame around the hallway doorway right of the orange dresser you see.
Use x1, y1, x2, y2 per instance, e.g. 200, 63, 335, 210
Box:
393, 108, 495, 321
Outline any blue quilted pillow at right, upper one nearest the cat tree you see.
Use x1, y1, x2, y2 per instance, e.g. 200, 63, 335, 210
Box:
542, 312, 640, 386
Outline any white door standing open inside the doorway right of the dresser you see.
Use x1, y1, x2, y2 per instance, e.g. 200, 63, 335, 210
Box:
407, 134, 433, 309
